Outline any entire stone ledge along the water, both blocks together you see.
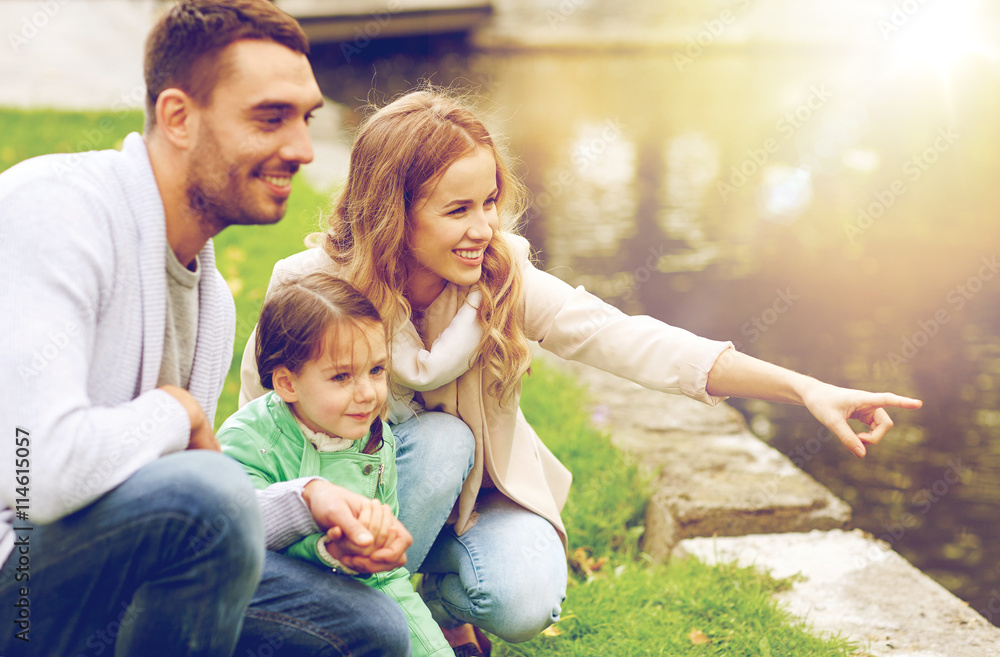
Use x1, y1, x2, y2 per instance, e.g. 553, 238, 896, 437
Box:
535, 351, 1000, 657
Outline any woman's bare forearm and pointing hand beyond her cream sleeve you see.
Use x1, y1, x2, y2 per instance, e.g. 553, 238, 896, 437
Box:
706, 349, 923, 458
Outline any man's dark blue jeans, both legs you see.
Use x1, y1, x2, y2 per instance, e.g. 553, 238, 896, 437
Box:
0, 451, 409, 657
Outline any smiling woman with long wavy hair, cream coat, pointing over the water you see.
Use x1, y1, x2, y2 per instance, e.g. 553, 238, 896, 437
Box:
242, 91, 920, 642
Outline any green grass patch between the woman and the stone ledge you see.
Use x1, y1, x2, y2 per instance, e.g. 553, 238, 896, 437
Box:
512, 364, 859, 657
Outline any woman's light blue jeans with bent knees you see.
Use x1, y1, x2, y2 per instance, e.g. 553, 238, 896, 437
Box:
392, 413, 567, 643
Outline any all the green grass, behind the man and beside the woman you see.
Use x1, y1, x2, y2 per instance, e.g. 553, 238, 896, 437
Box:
0, 108, 858, 657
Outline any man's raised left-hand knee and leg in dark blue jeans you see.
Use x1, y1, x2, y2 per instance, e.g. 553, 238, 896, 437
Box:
0, 451, 264, 657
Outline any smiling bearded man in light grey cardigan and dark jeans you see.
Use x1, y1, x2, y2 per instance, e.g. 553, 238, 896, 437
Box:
0, 0, 411, 657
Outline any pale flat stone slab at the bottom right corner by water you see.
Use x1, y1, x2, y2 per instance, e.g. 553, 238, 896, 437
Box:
677, 530, 1000, 657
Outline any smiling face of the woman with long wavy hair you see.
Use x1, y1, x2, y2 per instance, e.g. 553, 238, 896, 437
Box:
407, 148, 500, 307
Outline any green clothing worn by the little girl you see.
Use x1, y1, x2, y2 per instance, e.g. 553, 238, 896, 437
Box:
217, 391, 454, 657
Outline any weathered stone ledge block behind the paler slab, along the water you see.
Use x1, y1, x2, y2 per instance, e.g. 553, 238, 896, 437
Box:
535, 352, 851, 559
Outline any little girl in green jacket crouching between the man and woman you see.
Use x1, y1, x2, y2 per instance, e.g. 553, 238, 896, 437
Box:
218, 273, 454, 657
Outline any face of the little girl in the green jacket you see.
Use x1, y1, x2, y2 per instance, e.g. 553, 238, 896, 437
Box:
275, 321, 388, 440
